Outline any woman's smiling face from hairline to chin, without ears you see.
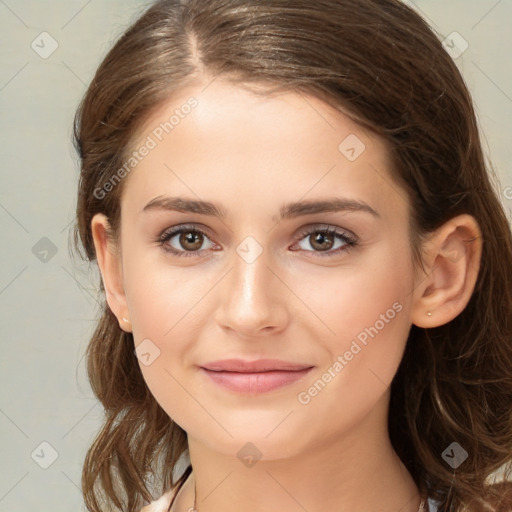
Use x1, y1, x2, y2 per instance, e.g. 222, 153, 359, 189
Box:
105, 80, 420, 458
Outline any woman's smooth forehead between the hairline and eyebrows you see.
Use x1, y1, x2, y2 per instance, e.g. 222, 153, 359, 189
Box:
120, 79, 404, 220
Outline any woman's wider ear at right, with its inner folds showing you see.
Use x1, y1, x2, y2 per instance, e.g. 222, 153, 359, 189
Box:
411, 214, 482, 328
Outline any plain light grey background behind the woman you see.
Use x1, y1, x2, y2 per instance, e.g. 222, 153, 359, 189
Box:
0, 0, 512, 512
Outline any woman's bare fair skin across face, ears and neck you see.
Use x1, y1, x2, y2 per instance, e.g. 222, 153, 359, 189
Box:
92, 79, 481, 512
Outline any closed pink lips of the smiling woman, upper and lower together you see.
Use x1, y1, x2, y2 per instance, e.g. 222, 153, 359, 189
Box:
201, 359, 313, 394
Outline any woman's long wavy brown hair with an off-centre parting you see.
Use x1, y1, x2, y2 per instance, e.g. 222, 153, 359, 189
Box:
74, 0, 512, 512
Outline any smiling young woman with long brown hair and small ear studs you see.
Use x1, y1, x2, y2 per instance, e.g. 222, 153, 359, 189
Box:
71, 0, 512, 512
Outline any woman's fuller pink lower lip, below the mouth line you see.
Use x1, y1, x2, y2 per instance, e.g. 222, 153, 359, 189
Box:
201, 367, 313, 394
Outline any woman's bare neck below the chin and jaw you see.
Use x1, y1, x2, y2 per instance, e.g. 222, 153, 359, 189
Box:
173, 398, 421, 512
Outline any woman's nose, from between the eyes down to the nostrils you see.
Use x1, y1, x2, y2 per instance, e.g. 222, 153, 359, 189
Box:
215, 242, 291, 338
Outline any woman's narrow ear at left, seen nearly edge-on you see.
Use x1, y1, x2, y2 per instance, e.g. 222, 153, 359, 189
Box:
91, 213, 131, 332
